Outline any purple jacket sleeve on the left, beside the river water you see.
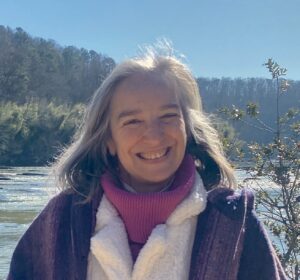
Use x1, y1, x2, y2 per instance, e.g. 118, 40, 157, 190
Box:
7, 191, 72, 280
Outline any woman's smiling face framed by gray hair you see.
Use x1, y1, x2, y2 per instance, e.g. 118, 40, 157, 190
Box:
107, 72, 187, 192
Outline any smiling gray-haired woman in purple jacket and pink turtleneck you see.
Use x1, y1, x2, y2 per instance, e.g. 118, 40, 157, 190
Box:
8, 48, 285, 280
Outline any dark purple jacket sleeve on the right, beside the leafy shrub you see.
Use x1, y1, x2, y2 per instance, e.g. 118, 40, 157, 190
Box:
238, 209, 287, 280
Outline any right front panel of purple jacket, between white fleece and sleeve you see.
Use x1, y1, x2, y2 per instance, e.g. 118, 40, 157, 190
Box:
189, 188, 247, 280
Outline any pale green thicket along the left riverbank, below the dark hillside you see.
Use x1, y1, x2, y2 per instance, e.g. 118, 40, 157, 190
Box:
0, 102, 85, 165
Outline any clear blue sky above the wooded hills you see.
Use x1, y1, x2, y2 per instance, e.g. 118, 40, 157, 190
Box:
0, 0, 300, 80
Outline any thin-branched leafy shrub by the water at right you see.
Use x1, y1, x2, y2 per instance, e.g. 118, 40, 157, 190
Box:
219, 59, 300, 280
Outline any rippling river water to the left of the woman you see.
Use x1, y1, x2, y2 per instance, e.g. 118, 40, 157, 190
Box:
0, 167, 56, 280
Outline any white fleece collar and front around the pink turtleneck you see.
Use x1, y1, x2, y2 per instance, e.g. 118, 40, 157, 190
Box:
87, 174, 207, 280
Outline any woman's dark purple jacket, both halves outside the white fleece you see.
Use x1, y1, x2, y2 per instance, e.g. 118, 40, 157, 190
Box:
7, 188, 287, 280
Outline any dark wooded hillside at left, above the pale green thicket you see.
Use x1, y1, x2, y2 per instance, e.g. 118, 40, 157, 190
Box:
0, 25, 115, 105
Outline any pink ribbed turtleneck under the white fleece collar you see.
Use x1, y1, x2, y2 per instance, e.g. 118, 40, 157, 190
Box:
101, 156, 195, 260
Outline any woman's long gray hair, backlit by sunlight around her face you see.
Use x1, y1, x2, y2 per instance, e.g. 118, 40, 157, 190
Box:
54, 48, 236, 201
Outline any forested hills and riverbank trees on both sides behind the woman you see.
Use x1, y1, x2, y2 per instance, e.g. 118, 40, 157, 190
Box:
0, 26, 300, 166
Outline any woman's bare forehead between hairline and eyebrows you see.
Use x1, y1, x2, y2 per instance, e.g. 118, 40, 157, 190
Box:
110, 74, 179, 111
